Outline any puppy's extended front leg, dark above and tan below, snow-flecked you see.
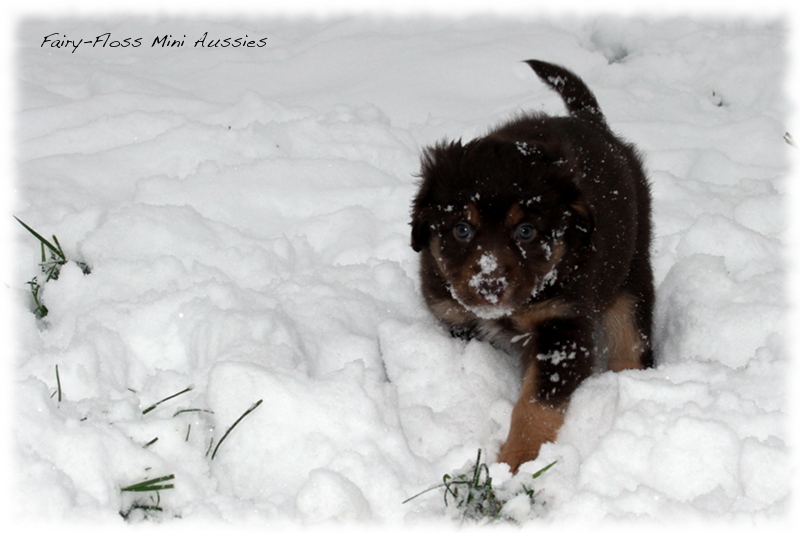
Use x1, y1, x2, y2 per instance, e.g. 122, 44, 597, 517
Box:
497, 319, 594, 472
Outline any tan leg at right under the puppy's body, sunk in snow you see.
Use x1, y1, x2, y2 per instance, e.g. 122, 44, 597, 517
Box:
603, 294, 647, 372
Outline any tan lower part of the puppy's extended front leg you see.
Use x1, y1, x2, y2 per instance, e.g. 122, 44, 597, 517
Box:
497, 363, 564, 473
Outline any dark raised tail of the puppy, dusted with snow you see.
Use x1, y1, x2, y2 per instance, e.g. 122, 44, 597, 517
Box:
525, 59, 608, 129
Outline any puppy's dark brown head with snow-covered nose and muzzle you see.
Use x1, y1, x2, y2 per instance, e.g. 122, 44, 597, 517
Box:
411, 136, 593, 318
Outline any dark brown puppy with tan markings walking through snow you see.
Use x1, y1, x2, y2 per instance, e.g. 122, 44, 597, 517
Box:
411, 60, 654, 471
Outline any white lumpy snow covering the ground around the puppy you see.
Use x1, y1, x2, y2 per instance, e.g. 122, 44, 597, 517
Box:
4, 11, 800, 525
